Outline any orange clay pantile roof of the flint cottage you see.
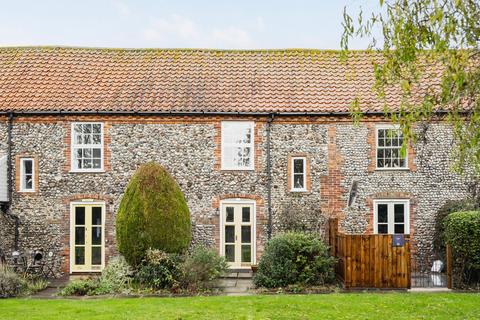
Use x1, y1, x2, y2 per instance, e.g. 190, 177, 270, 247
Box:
0, 47, 399, 113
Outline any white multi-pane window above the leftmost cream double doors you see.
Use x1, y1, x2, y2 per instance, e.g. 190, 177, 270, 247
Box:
71, 123, 103, 172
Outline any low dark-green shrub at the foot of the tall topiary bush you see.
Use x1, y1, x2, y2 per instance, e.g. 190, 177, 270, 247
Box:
135, 249, 181, 290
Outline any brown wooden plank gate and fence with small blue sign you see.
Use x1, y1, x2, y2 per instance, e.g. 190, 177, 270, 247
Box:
329, 219, 410, 289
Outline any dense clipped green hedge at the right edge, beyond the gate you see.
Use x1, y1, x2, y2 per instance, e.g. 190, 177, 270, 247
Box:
445, 211, 480, 287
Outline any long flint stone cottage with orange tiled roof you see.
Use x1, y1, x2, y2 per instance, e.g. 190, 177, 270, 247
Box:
0, 47, 468, 274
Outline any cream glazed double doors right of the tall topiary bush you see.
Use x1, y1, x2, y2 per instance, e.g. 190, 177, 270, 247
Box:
222, 203, 255, 268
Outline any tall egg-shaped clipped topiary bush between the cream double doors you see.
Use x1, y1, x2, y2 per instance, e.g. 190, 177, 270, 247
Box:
116, 162, 192, 266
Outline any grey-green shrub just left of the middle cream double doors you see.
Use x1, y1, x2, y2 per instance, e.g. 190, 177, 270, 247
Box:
181, 246, 228, 291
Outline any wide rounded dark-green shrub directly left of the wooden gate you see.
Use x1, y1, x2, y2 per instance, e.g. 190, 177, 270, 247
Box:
253, 232, 335, 288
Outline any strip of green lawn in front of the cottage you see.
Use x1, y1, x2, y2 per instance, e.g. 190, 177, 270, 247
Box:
0, 293, 480, 320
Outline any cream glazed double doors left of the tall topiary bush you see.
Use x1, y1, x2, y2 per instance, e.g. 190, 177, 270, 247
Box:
71, 204, 105, 272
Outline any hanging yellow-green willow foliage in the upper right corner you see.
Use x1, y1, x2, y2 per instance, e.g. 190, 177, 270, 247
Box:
341, 0, 480, 177
